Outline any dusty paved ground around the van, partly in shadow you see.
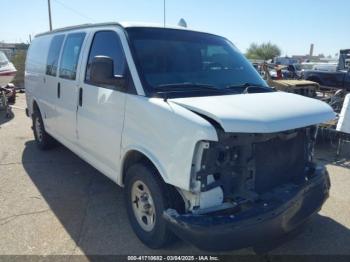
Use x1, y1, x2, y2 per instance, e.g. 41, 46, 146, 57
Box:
0, 94, 350, 255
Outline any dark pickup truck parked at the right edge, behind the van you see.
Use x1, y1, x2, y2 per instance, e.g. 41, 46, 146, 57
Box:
303, 49, 350, 91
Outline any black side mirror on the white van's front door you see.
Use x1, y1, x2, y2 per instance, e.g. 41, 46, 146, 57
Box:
90, 56, 126, 89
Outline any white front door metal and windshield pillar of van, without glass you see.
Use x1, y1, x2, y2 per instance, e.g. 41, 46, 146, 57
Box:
76, 26, 144, 182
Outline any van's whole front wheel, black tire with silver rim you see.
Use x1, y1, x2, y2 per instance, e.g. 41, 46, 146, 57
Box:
124, 163, 183, 249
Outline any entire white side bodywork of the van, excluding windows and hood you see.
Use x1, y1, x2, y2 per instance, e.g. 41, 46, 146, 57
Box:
26, 26, 218, 190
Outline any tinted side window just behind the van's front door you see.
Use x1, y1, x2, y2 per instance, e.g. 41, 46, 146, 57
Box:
60, 33, 85, 80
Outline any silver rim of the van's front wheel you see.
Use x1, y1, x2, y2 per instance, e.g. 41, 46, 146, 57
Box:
131, 180, 156, 232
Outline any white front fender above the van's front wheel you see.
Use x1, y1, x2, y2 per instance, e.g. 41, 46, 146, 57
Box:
119, 95, 218, 190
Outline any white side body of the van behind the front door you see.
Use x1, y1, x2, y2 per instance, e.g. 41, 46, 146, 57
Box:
25, 27, 124, 181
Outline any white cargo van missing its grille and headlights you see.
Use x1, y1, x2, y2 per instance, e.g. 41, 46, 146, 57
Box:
25, 23, 334, 250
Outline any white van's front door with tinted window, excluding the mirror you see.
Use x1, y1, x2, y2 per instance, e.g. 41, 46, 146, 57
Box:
77, 30, 126, 179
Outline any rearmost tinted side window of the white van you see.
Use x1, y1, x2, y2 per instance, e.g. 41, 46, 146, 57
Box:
46, 35, 64, 76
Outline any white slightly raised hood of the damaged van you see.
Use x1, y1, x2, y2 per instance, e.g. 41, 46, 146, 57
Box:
168, 92, 335, 133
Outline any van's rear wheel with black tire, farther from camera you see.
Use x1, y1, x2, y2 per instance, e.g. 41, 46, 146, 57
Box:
32, 108, 55, 150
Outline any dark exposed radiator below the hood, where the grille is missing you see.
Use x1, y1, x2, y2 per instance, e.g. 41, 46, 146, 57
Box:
254, 130, 306, 193
